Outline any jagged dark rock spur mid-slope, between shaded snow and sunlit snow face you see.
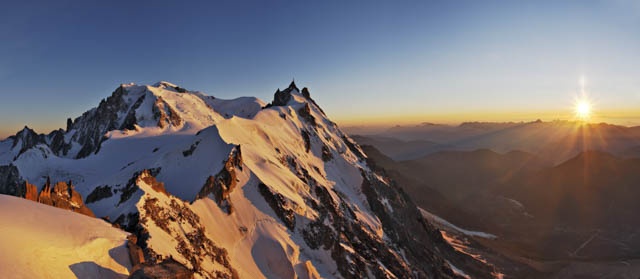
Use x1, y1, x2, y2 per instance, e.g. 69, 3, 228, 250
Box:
196, 145, 242, 214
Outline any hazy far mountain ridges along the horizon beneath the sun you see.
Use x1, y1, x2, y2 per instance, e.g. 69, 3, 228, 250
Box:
356, 121, 640, 163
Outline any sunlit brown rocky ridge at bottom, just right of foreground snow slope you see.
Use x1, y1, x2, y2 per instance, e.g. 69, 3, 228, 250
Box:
115, 170, 238, 279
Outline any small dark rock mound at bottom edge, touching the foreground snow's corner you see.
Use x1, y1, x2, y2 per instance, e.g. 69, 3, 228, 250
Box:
129, 258, 194, 279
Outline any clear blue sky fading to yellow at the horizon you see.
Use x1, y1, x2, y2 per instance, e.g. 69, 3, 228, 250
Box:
0, 0, 640, 137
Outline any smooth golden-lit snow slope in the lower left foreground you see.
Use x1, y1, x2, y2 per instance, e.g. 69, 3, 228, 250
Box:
0, 195, 131, 278
